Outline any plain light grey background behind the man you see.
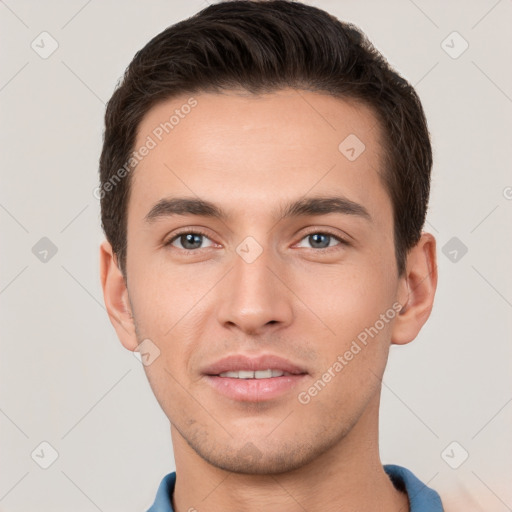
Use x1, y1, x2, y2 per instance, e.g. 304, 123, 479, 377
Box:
0, 0, 512, 512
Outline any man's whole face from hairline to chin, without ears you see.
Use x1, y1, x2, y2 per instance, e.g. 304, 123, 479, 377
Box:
121, 90, 408, 474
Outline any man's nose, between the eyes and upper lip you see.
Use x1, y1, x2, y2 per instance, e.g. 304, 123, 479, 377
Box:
218, 240, 293, 335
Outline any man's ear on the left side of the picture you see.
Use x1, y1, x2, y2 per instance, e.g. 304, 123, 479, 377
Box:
100, 240, 137, 351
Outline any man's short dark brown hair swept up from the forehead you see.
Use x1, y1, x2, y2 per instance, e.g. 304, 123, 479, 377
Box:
99, 0, 432, 277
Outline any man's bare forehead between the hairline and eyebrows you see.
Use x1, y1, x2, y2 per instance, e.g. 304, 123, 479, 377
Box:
129, 89, 387, 224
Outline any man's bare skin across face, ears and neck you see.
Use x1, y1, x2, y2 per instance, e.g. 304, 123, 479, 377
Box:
100, 89, 437, 512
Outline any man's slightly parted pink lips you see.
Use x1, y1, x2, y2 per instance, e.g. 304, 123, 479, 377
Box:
202, 354, 308, 402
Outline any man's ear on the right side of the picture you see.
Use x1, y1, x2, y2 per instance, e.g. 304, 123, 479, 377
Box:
391, 233, 437, 345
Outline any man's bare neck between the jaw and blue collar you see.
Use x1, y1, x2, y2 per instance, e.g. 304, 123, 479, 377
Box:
171, 400, 409, 512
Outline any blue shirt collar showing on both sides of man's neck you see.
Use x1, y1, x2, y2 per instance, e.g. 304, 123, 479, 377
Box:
147, 464, 443, 512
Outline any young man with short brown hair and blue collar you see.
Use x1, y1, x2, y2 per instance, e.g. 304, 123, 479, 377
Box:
100, 0, 443, 512
